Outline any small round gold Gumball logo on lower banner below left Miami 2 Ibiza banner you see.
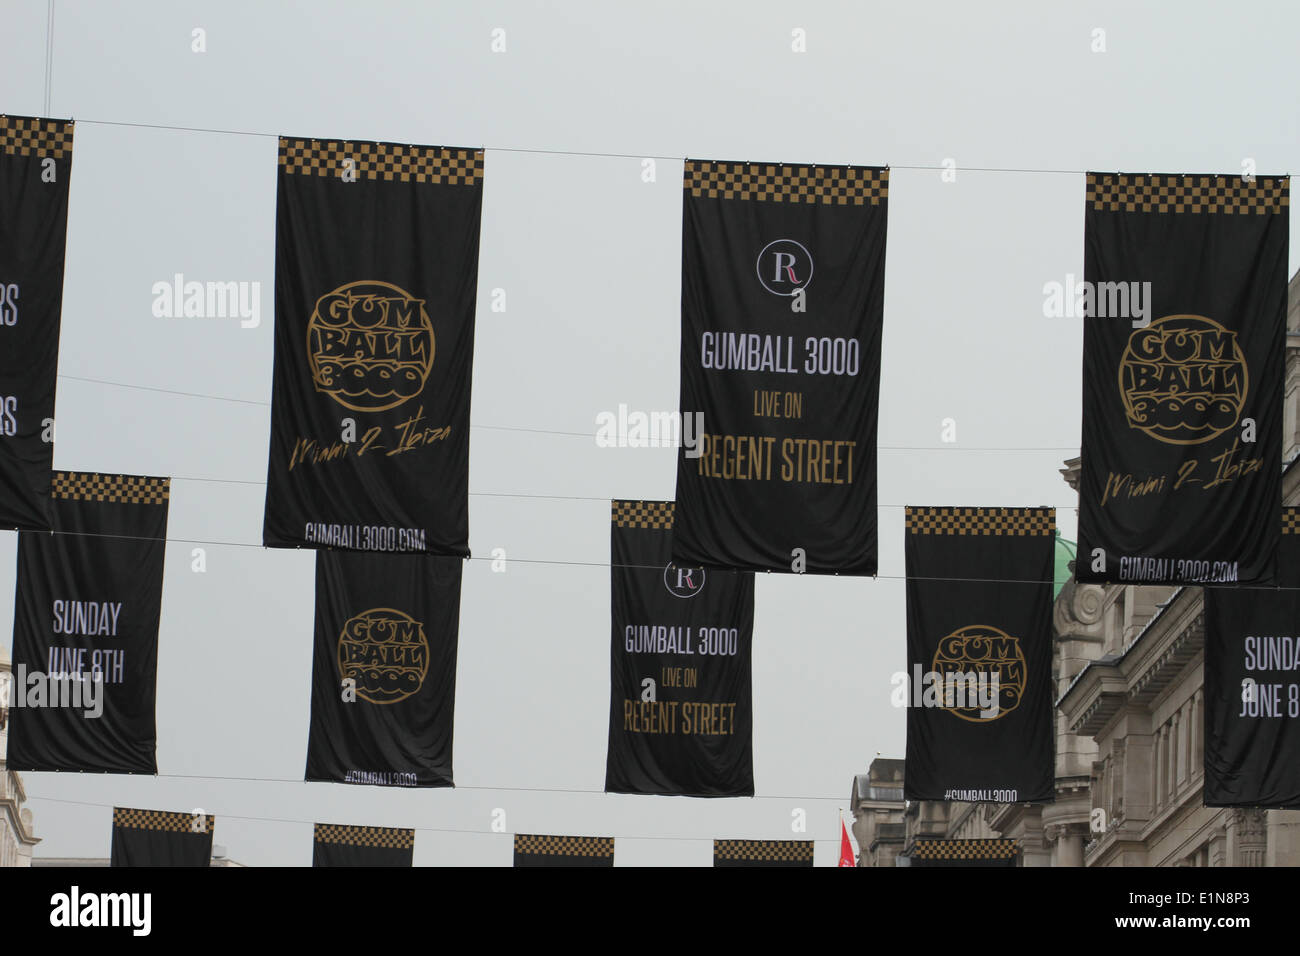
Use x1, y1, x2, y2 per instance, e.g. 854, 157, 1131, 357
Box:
338, 607, 429, 704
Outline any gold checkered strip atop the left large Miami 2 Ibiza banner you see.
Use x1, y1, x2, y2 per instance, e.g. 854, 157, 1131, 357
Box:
280, 137, 484, 186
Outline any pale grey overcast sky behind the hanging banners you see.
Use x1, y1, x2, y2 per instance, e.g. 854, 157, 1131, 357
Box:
0, 0, 1300, 865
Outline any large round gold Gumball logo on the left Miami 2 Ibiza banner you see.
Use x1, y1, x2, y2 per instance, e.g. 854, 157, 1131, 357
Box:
307, 280, 434, 411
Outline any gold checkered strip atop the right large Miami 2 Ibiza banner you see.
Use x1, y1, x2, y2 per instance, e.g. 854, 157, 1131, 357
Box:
1088, 173, 1291, 216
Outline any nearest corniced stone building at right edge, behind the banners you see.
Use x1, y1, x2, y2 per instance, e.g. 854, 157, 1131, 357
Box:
1057, 455, 1300, 866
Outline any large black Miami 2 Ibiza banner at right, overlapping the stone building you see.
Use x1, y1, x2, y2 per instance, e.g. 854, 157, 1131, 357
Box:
1066, 173, 1290, 584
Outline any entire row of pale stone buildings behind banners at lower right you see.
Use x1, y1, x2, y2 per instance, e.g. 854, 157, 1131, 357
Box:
854, 273, 1300, 866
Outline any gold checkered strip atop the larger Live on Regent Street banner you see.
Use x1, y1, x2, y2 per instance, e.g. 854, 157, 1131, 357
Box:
683, 160, 889, 206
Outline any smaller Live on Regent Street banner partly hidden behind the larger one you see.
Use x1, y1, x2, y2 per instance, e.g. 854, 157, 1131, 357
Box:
605, 501, 754, 796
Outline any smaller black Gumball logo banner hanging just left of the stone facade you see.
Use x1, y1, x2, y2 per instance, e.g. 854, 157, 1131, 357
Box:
893, 507, 1056, 804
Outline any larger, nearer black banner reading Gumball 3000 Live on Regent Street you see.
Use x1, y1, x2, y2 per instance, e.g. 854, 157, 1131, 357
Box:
672, 160, 889, 575
